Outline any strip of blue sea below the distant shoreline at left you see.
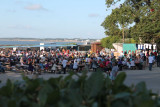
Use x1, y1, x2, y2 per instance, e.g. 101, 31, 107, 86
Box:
0, 40, 84, 45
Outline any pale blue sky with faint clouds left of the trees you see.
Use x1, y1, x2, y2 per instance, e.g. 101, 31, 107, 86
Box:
0, 0, 115, 39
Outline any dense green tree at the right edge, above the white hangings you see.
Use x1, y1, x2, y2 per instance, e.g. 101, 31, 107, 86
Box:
131, 0, 160, 50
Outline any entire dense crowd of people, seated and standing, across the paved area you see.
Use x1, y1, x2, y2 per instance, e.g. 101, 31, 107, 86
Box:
0, 49, 160, 80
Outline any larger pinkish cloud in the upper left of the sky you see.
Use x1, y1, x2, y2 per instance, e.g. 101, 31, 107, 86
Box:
25, 4, 48, 11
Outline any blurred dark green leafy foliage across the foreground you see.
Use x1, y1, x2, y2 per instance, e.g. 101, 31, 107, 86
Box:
0, 72, 160, 107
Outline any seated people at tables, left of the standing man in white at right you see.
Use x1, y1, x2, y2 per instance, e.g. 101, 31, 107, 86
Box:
0, 47, 159, 74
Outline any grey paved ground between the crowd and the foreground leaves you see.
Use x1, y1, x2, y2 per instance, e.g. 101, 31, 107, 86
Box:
0, 67, 160, 93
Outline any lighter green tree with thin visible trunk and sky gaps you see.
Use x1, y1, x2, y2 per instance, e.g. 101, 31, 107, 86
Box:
102, 5, 133, 43
